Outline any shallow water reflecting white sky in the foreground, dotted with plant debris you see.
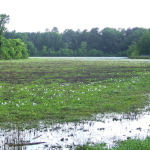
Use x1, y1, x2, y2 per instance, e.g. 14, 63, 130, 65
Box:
0, 111, 150, 150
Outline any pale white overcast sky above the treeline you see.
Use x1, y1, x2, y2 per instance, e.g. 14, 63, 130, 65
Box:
0, 0, 150, 32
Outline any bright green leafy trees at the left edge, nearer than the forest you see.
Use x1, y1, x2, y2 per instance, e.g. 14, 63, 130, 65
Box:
0, 14, 28, 59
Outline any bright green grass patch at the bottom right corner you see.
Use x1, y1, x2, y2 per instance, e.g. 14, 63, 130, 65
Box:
76, 138, 150, 150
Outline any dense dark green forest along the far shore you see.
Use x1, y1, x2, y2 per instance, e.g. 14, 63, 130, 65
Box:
4, 27, 150, 56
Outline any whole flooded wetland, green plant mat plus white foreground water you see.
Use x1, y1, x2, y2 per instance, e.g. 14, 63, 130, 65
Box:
0, 58, 150, 150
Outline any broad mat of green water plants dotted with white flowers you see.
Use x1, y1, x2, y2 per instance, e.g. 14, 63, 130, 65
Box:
0, 58, 150, 123
